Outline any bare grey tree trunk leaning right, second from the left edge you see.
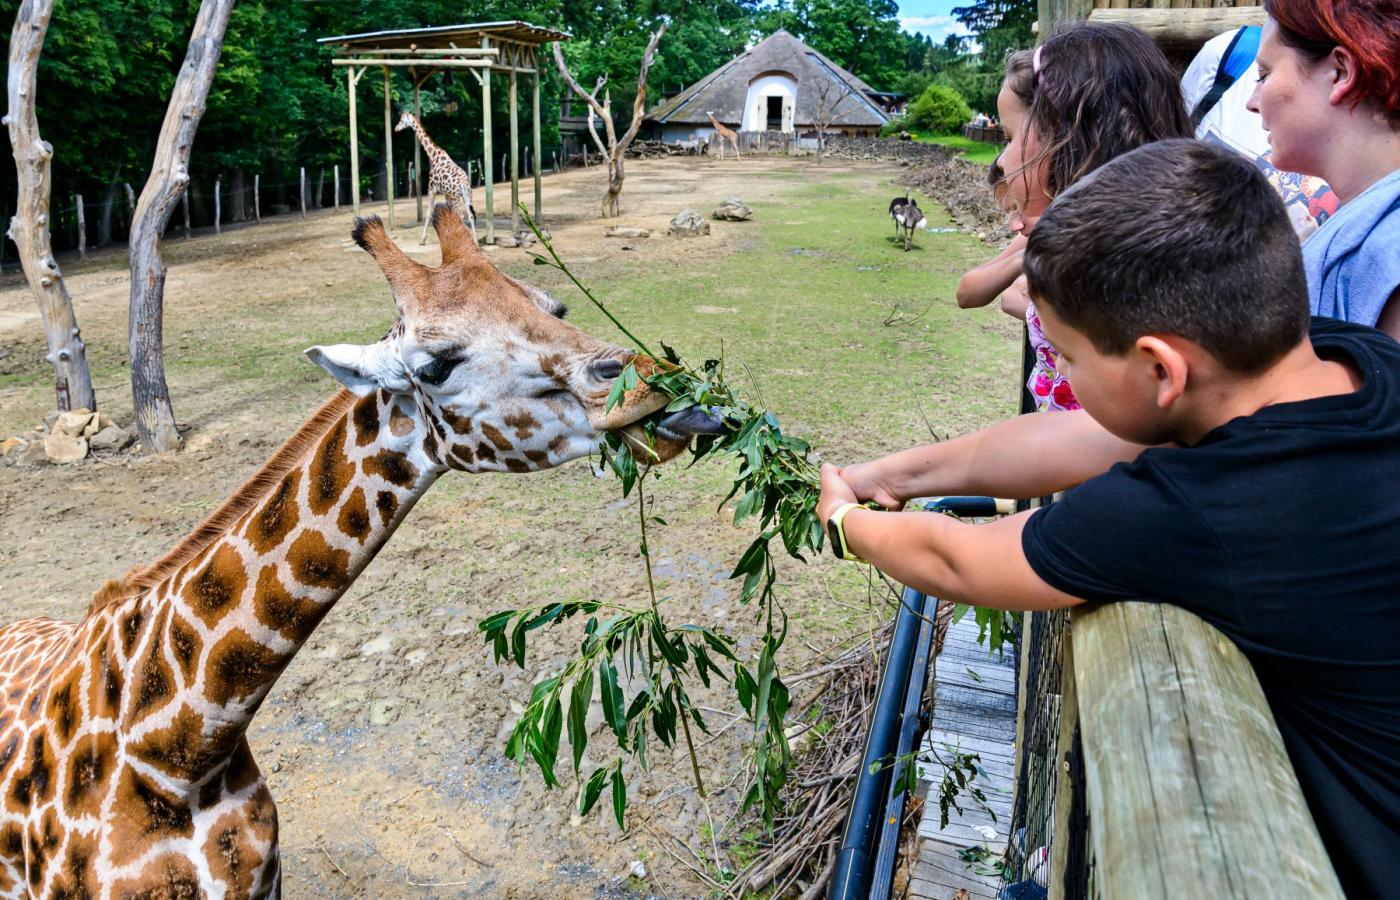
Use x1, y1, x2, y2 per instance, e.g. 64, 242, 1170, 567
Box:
129, 0, 234, 452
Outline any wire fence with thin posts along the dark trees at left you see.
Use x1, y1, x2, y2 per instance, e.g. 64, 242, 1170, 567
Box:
9, 144, 568, 265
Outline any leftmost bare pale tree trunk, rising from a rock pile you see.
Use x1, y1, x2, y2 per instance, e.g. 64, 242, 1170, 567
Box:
4, 0, 97, 410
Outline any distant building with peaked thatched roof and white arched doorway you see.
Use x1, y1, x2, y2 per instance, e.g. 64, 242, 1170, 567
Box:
647, 31, 889, 141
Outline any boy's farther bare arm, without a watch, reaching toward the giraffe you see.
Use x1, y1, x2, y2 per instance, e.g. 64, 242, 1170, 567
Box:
840, 410, 1147, 509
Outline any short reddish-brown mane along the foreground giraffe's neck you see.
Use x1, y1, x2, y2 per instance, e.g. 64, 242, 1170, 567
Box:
88, 389, 357, 616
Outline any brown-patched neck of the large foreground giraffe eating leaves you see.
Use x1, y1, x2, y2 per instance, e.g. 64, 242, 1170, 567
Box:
111, 392, 445, 784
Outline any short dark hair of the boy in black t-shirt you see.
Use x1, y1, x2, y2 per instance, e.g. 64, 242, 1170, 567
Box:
1022, 139, 1309, 372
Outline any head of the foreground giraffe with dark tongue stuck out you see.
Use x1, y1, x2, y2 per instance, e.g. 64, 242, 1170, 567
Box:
307, 204, 708, 472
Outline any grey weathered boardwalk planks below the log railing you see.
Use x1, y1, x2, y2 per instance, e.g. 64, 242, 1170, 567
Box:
909, 613, 1016, 900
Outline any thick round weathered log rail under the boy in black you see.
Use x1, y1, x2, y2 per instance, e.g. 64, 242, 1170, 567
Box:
1056, 603, 1343, 900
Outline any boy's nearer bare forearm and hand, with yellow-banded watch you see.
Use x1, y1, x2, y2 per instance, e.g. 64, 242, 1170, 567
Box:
816, 465, 1084, 610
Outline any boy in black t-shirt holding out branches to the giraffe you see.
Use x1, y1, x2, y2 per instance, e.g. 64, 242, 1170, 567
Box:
818, 140, 1400, 897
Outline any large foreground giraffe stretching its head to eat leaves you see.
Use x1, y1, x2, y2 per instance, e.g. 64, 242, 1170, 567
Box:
0, 204, 711, 900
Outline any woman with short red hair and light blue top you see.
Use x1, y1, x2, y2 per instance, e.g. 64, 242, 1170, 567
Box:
1249, 0, 1400, 339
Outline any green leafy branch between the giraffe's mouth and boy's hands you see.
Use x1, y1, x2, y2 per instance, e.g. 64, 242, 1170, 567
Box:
479, 207, 825, 829
